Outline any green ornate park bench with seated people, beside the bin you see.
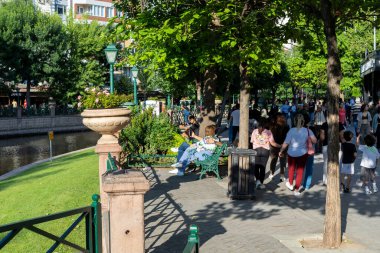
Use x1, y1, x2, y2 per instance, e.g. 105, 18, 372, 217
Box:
194, 143, 227, 180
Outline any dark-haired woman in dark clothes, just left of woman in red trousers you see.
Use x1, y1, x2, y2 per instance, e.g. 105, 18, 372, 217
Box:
269, 113, 289, 182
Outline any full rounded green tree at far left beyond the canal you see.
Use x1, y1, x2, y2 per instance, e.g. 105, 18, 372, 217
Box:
0, 0, 69, 105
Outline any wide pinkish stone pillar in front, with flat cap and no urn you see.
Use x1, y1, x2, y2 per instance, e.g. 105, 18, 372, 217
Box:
102, 170, 150, 253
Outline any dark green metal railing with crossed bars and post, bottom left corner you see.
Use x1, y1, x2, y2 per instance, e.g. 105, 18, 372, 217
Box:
0, 194, 102, 253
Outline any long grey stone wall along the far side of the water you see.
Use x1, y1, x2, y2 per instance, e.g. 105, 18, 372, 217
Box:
0, 115, 88, 137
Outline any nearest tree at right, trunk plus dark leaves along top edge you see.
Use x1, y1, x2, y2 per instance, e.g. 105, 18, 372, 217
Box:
287, 0, 378, 248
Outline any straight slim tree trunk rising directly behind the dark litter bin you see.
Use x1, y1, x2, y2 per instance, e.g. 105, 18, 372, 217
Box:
239, 62, 250, 149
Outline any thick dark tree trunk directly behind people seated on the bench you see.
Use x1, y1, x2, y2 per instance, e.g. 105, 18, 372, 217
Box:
199, 69, 217, 136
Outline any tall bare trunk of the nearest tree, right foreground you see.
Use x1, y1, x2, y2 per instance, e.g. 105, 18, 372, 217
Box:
321, 0, 342, 248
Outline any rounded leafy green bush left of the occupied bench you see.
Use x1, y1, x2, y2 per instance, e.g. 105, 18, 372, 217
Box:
119, 109, 177, 154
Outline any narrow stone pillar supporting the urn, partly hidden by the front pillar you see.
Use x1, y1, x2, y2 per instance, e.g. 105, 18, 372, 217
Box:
95, 142, 122, 253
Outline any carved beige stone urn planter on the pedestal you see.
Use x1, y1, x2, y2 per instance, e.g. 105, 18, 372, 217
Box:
81, 108, 131, 144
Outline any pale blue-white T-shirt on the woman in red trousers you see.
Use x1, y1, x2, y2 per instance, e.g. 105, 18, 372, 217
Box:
284, 127, 314, 157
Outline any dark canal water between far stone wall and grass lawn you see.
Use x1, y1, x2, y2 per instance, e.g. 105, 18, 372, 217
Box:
0, 131, 100, 175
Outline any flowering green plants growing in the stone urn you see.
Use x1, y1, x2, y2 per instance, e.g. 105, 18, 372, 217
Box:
77, 88, 133, 109
